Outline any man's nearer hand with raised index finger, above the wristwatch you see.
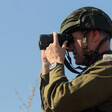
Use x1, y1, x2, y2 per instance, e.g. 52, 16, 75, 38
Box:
45, 32, 67, 64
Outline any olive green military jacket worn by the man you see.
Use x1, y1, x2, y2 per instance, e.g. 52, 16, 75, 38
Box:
40, 54, 112, 112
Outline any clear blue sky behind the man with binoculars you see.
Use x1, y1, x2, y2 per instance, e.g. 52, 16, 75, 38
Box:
0, 0, 112, 112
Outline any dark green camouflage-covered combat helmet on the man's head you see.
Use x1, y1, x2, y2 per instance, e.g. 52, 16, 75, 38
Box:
60, 7, 112, 36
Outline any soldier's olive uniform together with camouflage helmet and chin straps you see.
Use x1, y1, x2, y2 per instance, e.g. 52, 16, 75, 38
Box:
40, 7, 112, 112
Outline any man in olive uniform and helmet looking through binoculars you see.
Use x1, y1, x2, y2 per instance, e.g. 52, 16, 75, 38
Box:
40, 7, 112, 112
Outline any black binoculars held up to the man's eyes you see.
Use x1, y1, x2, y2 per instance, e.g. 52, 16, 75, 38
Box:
39, 34, 73, 50
